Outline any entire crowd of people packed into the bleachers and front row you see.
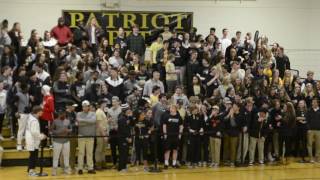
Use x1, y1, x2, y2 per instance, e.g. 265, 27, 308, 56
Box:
0, 15, 320, 176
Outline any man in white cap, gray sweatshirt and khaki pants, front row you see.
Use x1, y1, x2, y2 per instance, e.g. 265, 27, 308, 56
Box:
77, 100, 96, 175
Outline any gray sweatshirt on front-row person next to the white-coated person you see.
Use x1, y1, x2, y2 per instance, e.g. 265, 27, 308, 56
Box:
52, 119, 71, 143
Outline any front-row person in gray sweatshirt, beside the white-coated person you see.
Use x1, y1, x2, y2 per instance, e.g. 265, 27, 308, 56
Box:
51, 109, 72, 176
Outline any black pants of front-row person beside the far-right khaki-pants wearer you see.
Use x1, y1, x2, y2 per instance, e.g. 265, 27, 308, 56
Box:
295, 127, 307, 159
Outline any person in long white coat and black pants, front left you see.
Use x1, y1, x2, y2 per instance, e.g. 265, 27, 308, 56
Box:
25, 106, 46, 176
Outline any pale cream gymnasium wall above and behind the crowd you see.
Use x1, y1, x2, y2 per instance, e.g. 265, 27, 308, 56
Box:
0, 0, 320, 79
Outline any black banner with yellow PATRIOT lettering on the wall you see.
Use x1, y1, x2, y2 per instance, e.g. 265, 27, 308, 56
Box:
62, 10, 193, 44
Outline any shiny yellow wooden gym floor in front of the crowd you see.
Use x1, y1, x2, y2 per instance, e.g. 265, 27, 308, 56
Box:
0, 163, 320, 180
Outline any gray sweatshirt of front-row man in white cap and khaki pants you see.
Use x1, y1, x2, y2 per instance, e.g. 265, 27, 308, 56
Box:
77, 111, 96, 136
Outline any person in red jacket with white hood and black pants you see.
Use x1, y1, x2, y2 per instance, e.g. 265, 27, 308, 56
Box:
39, 85, 54, 145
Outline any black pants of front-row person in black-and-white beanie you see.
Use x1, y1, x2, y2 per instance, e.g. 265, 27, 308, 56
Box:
118, 138, 129, 171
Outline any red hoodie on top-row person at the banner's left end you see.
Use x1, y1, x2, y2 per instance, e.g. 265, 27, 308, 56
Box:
51, 26, 72, 46
